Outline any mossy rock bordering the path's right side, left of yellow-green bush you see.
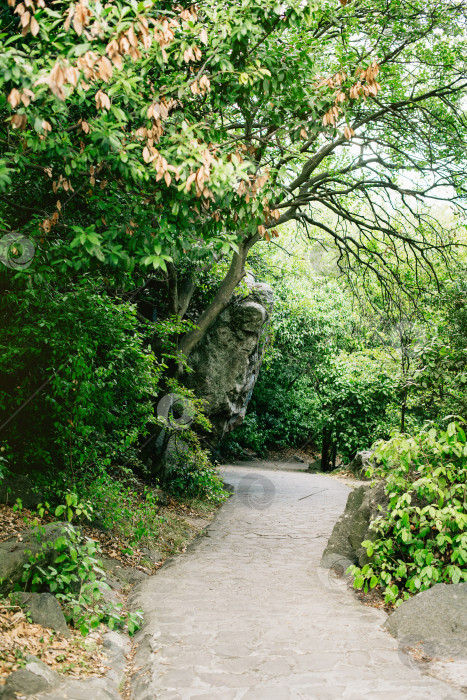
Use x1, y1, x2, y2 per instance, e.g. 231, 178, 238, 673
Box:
320, 482, 388, 573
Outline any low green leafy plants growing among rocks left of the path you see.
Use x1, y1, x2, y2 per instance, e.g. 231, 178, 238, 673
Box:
22, 525, 142, 636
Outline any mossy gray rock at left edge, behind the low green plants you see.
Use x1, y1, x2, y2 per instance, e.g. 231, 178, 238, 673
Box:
0, 523, 76, 593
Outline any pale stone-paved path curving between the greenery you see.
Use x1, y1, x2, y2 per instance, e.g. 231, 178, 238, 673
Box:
133, 467, 466, 700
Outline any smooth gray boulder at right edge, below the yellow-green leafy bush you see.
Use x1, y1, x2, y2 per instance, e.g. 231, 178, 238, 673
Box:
384, 583, 467, 660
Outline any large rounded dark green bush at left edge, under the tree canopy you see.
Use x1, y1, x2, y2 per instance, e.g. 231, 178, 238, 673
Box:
0, 285, 161, 477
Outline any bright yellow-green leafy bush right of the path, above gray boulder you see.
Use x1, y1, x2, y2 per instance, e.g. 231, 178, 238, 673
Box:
350, 420, 467, 605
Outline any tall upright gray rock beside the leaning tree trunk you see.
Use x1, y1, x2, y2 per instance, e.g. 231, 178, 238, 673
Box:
186, 276, 273, 439
